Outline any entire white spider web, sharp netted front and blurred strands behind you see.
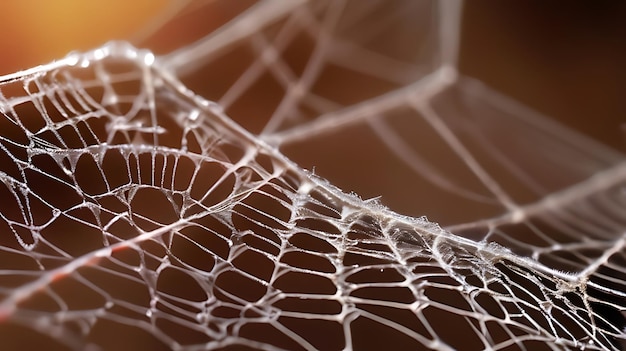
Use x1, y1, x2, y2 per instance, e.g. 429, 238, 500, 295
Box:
0, 1, 626, 350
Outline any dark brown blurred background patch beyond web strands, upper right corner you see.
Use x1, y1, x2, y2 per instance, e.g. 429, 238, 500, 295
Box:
460, 0, 626, 150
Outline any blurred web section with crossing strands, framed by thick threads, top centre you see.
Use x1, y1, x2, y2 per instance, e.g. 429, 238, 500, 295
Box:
165, 1, 441, 137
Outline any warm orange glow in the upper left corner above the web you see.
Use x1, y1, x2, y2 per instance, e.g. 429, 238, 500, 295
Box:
0, 0, 167, 74
